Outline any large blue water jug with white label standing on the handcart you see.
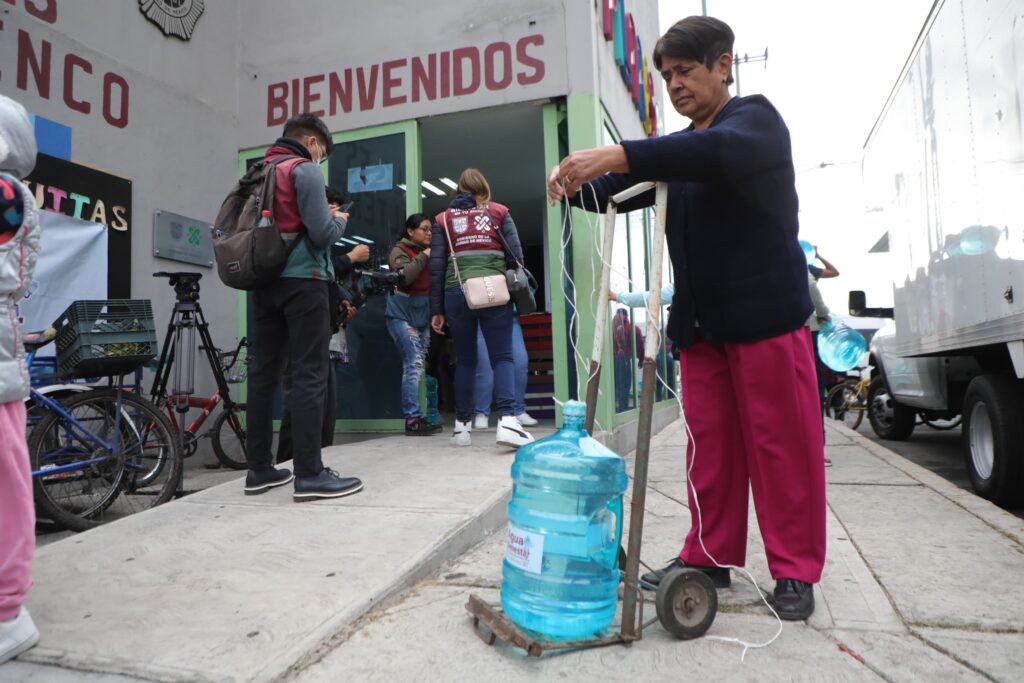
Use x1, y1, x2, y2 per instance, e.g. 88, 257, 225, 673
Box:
502, 401, 628, 640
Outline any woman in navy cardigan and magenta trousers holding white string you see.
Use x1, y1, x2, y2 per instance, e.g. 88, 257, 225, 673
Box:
548, 16, 825, 620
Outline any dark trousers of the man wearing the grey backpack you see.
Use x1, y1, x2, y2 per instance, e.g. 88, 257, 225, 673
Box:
246, 278, 331, 477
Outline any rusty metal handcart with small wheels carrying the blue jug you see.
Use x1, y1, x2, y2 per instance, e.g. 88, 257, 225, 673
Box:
466, 182, 718, 656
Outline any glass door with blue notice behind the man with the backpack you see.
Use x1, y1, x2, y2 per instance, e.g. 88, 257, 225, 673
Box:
326, 121, 422, 431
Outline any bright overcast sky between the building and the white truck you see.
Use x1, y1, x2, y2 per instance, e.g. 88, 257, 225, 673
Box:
655, 0, 933, 305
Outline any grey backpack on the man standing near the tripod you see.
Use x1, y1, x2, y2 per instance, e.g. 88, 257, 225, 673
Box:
213, 156, 305, 290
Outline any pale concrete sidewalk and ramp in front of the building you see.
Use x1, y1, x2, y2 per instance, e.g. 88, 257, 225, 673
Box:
8, 422, 1024, 683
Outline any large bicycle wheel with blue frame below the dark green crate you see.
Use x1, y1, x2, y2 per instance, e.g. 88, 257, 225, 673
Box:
30, 389, 182, 530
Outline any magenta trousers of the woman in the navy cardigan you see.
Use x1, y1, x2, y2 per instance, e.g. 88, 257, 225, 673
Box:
679, 328, 825, 584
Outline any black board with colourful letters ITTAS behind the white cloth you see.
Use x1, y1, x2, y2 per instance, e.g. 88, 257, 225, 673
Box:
25, 154, 131, 299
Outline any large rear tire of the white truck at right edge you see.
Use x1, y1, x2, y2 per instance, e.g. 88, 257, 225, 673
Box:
964, 375, 1024, 507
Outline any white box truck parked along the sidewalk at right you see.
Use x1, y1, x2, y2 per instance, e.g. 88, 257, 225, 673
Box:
850, 0, 1024, 507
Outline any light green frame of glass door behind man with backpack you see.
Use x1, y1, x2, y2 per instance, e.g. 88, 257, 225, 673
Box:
237, 120, 423, 431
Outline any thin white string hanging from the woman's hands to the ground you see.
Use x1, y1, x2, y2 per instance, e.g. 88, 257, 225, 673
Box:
558, 183, 782, 661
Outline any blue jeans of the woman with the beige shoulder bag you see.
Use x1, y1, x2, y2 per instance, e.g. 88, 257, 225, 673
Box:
444, 288, 516, 422
